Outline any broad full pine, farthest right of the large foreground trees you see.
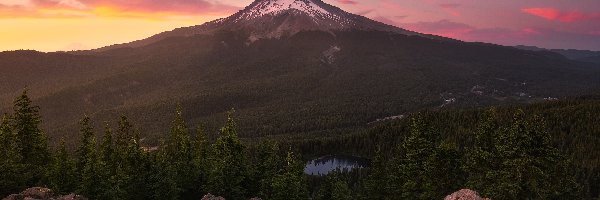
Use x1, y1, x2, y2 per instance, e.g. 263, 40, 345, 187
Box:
484, 110, 578, 199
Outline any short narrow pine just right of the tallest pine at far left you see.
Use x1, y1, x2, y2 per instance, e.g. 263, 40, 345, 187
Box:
48, 140, 79, 194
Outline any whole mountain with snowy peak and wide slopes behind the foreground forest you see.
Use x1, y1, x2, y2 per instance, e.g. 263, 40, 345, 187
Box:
0, 0, 600, 143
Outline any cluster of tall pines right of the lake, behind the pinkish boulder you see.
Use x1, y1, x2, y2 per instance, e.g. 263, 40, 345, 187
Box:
358, 109, 583, 199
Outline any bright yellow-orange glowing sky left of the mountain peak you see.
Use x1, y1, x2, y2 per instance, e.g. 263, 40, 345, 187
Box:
0, 4, 234, 52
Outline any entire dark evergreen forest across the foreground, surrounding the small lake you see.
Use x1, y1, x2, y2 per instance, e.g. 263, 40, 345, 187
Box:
0, 92, 600, 200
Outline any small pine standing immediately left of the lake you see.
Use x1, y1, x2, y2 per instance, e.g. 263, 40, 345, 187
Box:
269, 152, 310, 200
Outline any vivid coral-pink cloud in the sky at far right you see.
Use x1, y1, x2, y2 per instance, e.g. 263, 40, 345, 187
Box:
521, 8, 600, 22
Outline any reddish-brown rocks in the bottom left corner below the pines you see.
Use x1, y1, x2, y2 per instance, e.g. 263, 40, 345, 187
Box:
2, 187, 87, 200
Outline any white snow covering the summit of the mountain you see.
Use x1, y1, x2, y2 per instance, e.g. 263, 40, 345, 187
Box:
238, 0, 336, 20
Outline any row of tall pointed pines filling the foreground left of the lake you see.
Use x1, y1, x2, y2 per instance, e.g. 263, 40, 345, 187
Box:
0, 91, 309, 199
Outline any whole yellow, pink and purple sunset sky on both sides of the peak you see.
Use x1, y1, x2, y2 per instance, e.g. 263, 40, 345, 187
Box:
0, 0, 600, 51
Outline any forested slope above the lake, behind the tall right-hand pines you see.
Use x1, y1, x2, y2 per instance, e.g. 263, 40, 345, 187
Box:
284, 96, 600, 198
